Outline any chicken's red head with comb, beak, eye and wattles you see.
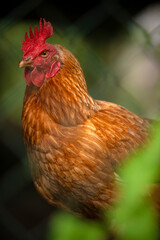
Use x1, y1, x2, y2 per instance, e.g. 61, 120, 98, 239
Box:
19, 19, 61, 87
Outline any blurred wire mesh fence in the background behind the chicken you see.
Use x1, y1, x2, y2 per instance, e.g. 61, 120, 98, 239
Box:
0, 0, 160, 240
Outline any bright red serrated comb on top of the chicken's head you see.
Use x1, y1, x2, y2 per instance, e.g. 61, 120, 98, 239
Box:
22, 18, 53, 52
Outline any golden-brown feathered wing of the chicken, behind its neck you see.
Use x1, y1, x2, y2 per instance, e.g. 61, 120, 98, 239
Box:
92, 101, 151, 166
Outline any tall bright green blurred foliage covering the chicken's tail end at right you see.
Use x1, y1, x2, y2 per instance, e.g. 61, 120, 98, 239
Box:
111, 124, 160, 240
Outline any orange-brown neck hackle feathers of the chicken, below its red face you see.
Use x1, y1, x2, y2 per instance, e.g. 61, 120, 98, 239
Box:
39, 61, 98, 126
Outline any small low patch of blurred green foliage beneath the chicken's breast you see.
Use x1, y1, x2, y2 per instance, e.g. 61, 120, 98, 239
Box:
47, 212, 105, 240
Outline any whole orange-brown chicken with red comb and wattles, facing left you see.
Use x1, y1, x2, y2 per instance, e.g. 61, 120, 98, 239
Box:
19, 19, 155, 218
